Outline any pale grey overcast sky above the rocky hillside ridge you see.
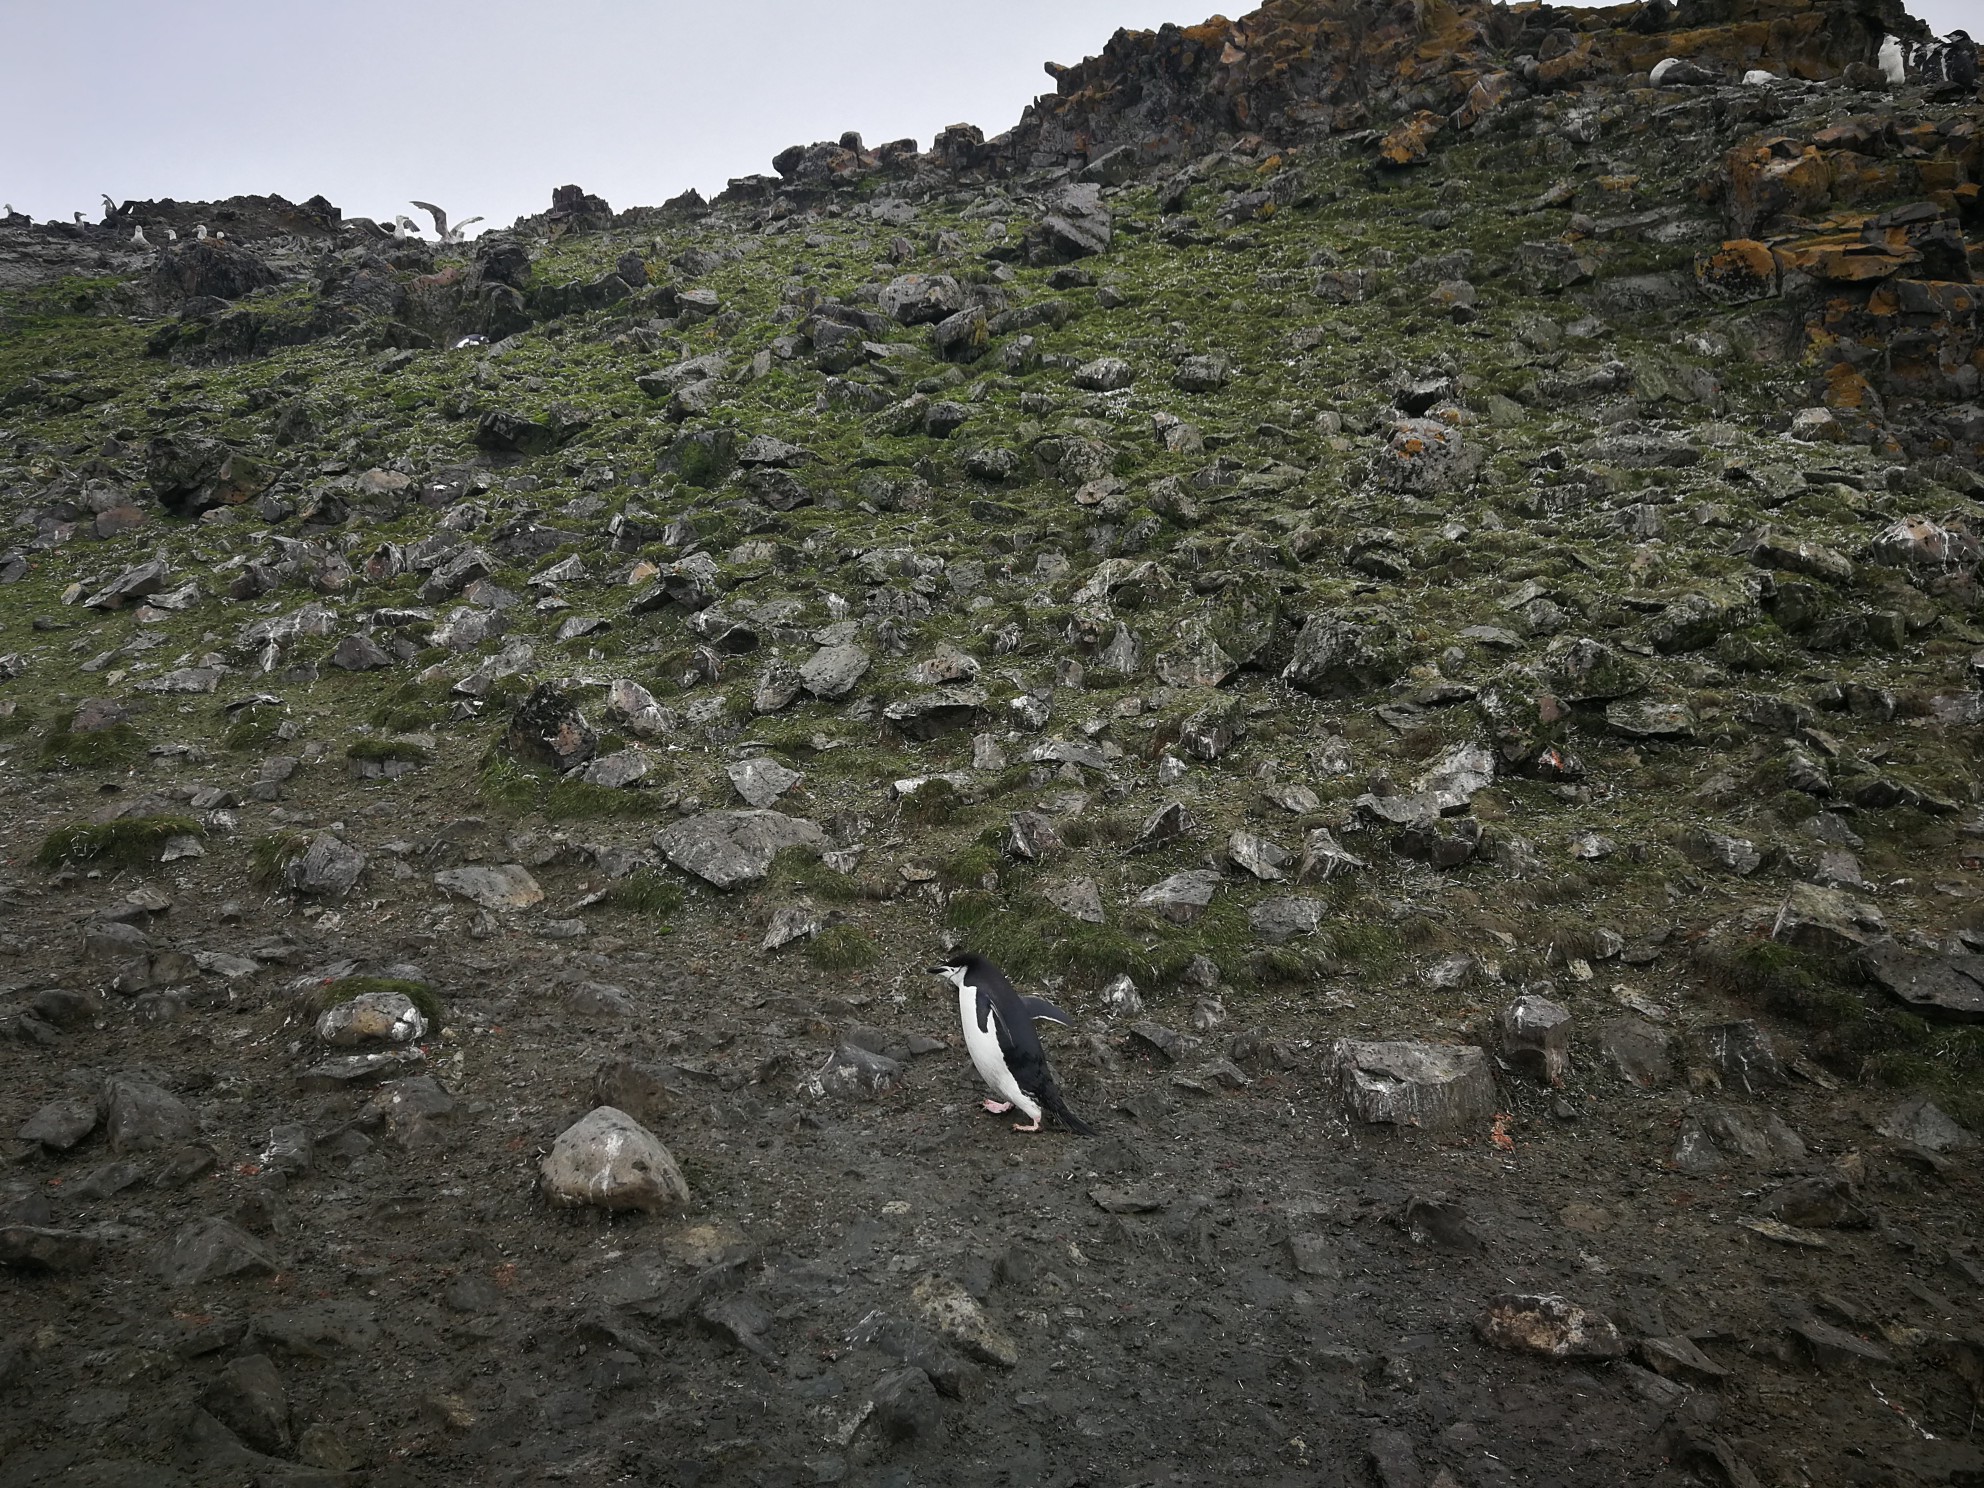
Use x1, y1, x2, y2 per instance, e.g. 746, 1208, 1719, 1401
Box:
0, 0, 1984, 226
